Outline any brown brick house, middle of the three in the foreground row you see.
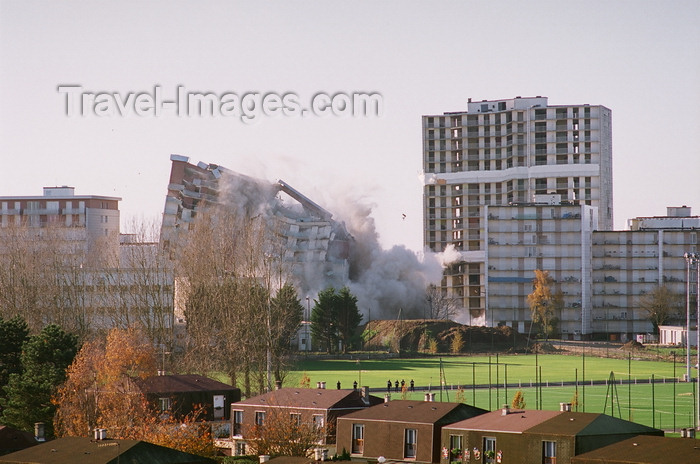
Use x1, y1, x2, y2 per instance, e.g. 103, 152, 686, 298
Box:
337, 400, 487, 463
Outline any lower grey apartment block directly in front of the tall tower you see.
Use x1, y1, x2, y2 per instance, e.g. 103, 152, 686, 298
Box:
484, 202, 598, 338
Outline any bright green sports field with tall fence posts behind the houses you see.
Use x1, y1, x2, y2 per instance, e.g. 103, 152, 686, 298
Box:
285, 355, 697, 430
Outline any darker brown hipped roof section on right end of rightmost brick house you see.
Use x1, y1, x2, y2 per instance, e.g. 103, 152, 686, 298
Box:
528, 412, 663, 436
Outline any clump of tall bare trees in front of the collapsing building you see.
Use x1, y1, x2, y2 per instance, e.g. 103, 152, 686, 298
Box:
171, 207, 301, 395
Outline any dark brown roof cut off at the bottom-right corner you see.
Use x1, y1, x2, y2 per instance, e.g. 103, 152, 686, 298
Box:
571, 435, 700, 464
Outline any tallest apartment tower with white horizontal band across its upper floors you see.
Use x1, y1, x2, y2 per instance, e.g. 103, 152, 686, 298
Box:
423, 96, 613, 325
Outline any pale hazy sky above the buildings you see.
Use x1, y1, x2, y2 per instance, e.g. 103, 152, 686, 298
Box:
0, 0, 700, 250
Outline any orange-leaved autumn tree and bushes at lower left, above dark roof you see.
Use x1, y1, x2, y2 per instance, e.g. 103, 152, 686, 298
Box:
53, 328, 214, 456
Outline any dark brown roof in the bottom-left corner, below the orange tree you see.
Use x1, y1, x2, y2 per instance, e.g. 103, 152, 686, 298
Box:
0, 437, 215, 464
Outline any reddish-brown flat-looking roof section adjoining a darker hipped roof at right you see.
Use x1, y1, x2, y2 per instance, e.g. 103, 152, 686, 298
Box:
445, 409, 561, 433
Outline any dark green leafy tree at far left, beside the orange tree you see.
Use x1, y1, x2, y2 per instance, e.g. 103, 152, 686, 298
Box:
0, 324, 78, 437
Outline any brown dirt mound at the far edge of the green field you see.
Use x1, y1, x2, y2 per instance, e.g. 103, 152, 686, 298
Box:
364, 319, 527, 353
